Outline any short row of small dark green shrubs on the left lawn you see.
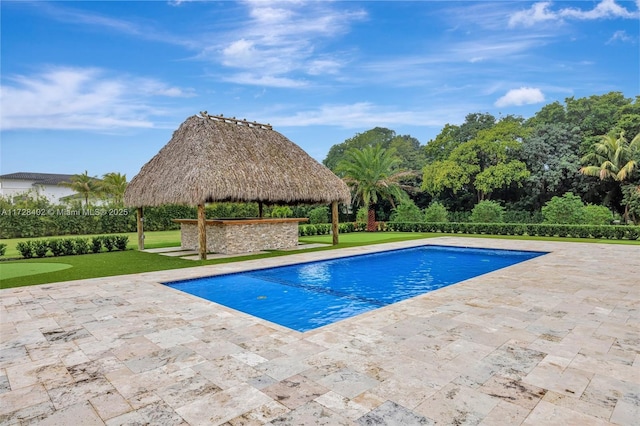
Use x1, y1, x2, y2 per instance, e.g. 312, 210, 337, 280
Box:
16, 235, 129, 259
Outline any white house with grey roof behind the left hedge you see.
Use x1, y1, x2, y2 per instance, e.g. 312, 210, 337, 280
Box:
0, 172, 75, 204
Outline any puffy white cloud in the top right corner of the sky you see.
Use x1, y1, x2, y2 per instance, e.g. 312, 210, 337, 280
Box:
509, 0, 640, 28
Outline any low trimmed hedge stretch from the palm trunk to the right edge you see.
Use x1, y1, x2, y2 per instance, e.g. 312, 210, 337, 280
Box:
386, 222, 640, 240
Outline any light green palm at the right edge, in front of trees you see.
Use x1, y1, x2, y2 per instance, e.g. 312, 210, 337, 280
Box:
580, 132, 640, 222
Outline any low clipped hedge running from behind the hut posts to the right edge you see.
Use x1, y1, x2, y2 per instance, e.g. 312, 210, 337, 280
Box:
298, 222, 640, 240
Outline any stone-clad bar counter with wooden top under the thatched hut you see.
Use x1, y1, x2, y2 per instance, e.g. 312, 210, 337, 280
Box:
173, 218, 308, 254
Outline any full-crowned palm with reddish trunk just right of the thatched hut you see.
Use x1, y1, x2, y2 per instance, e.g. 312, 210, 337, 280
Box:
337, 145, 414, 231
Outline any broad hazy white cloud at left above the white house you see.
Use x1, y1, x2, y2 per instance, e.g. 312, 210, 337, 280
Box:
0, 68, 194, 130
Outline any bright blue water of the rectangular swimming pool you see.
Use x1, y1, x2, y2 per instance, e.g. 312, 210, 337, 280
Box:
165, 246, 545, 331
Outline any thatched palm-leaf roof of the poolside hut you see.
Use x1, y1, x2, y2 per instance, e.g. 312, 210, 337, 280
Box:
125, 113, 350, 207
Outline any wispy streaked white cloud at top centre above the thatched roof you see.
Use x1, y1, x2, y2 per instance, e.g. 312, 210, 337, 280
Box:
215, 1, 366, 87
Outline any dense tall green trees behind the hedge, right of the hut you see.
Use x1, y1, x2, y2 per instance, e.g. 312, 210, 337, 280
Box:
323, 92, 640, 220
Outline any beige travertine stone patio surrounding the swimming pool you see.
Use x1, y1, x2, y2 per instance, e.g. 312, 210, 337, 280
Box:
0, 237, 640, 426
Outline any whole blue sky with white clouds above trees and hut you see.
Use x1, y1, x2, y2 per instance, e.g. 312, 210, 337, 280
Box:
0, 0, 640, 179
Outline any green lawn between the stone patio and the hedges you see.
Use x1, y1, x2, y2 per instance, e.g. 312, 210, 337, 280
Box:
0, 231, 640, 288
